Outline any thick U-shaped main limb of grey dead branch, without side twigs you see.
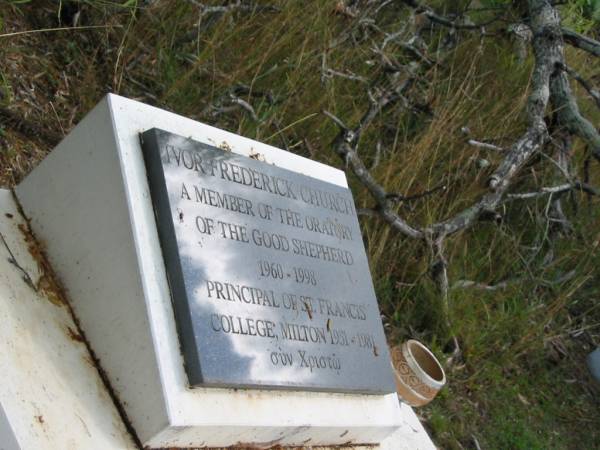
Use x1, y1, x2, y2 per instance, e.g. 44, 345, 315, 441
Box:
329, 0, 562, 243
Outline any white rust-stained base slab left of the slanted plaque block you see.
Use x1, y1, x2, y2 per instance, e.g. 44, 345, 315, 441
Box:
0, 190, 135, 450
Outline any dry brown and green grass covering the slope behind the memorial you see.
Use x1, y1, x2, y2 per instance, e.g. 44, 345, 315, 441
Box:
0, 0, 600, 449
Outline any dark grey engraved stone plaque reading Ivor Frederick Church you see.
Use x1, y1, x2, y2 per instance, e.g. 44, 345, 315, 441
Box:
142, 129, 395, 394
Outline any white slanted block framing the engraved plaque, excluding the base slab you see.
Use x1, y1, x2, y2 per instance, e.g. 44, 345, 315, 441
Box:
17, 95, 433, 449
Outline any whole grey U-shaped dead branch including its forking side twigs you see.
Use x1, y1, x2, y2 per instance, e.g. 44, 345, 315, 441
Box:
326, 0, 600, 342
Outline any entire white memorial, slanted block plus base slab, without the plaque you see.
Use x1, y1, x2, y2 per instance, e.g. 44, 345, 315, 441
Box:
0, 95, 434, 449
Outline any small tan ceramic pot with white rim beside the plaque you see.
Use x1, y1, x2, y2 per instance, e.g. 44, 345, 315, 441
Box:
391, 339, 446, 406
